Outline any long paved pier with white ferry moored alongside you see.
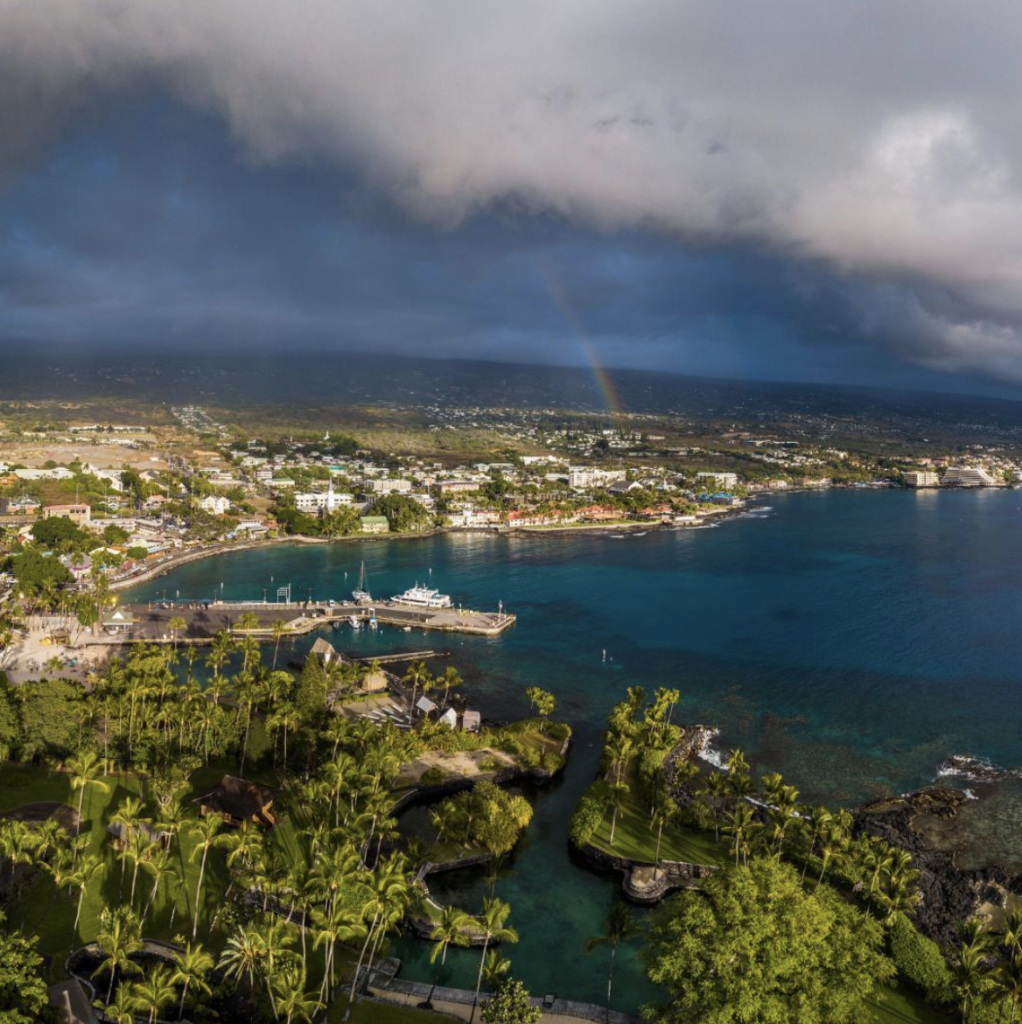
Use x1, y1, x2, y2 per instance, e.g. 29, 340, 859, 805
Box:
107, 601, 516, 645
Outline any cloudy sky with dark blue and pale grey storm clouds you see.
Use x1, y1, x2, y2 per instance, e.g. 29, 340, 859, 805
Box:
0, 0, 1022, 393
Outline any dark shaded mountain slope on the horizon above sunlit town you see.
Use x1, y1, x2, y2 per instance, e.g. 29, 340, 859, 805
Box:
0, 349, 1022, 439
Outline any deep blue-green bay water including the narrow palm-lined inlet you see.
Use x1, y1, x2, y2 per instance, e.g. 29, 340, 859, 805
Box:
132, 490, 1022, 1009
